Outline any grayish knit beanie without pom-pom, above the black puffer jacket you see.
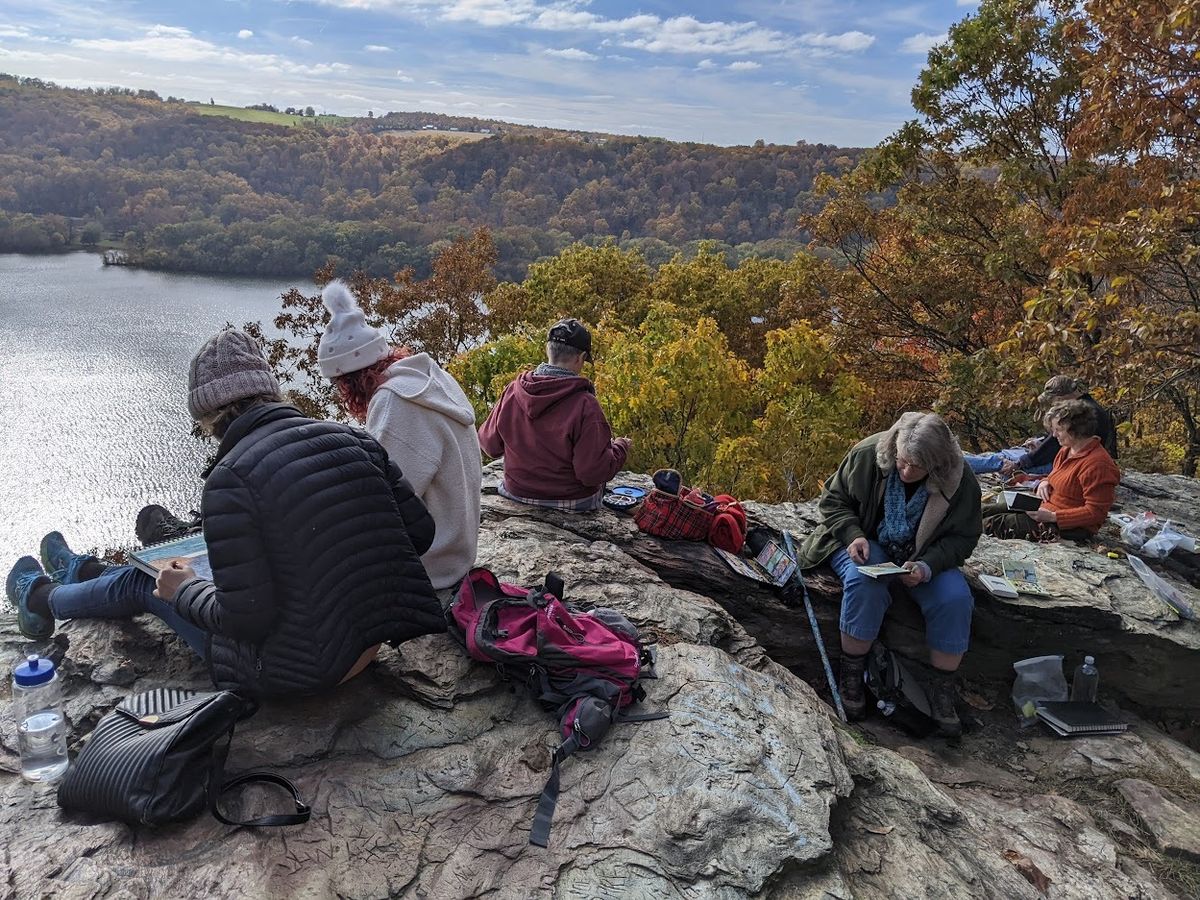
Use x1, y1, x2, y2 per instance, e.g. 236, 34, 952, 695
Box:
187, 328, 280, 420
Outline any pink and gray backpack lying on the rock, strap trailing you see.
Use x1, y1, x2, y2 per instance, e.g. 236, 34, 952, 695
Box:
448, 569, 666, 847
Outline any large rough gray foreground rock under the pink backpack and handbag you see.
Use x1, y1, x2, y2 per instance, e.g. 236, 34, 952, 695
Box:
0, 468, 1192, 900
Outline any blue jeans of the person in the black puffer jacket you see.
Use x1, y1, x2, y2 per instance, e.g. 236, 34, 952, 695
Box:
50, 565, 209, 660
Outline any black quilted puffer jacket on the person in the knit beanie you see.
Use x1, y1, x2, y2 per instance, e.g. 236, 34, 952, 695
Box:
174, 403, 445, 696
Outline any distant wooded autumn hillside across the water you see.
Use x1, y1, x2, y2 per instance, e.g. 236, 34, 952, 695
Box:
0, 76, 860, 277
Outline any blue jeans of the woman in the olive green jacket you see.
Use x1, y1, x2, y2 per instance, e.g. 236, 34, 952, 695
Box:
829, 541, 974, 653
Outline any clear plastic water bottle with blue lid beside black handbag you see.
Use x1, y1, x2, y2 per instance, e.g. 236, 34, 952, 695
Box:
12, 654, 68, 781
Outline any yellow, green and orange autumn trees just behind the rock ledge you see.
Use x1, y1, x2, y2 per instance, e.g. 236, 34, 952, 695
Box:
255, 0, 1200, 499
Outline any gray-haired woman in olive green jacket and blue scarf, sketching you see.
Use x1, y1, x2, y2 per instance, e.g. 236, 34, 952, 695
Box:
799, 413, 982, 734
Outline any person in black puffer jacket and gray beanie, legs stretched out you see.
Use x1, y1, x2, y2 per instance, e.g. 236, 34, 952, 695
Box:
7, 329, 445, 697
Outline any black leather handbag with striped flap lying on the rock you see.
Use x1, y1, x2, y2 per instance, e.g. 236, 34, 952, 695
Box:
59, 688, 311, 826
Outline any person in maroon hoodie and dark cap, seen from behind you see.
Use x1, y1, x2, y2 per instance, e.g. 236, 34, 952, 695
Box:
479, 319, 629, 511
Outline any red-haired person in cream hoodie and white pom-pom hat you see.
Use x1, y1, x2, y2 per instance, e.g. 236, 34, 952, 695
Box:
317, 281, 482, 602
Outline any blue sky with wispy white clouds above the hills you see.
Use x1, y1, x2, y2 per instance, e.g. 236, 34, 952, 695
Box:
0, 0, 977, 146
